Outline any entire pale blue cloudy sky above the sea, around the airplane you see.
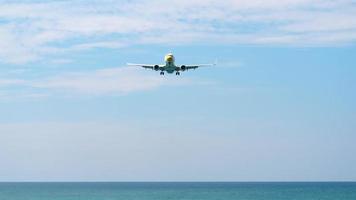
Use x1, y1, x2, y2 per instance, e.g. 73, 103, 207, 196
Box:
0, 0, 356, 181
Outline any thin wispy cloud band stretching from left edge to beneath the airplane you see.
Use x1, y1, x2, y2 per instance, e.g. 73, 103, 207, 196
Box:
0, 67, 193, 99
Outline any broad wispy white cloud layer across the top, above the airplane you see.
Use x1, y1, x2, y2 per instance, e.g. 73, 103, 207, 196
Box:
0, 0, 356, 63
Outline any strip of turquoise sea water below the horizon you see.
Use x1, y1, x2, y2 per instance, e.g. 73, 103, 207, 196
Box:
0, 183, 356, 200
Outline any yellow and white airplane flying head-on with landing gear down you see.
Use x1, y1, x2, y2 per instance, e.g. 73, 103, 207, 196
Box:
127, 53, 216, 75
